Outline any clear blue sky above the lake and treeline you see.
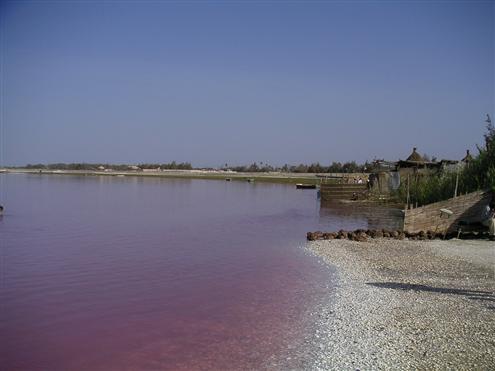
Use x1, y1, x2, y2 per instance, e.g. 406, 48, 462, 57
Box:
0, 1, 495, 166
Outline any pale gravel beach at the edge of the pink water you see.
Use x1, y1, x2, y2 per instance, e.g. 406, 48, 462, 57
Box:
308, 239, 495, 370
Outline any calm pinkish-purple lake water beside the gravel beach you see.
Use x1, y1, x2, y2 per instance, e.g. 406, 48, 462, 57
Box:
0, 174, 402, 370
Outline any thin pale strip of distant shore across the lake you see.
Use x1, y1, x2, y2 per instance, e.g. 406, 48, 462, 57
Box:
0, 168, 368, 184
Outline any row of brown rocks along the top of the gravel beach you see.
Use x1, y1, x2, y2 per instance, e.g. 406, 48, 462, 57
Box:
306, 229, 464, 242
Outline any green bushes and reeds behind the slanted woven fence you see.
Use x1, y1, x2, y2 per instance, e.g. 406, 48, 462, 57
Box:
399, 122, 495, 206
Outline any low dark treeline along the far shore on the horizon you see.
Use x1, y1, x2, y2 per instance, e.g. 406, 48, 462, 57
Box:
19, 161, 373, 173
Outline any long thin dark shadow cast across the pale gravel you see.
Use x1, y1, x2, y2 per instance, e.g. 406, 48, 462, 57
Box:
366, 282, 495, 310
